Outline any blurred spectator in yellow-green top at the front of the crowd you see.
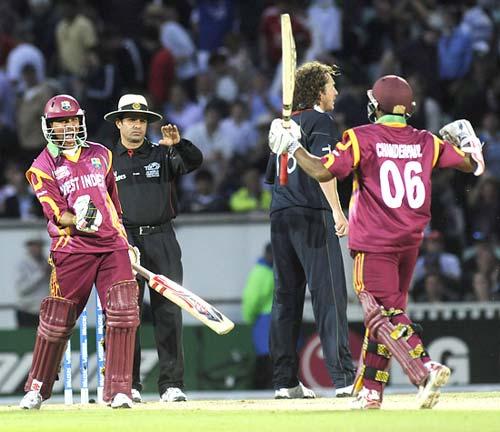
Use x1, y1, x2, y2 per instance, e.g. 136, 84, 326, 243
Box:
229, 168, 271, 213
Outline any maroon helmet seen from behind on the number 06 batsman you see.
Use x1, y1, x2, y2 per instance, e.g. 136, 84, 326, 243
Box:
367, 75, 415, 123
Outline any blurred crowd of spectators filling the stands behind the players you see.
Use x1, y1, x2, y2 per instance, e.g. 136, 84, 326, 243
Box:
0, 0, 500, 302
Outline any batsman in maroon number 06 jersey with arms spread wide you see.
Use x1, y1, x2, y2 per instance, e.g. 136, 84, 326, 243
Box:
269, 75, 485, 409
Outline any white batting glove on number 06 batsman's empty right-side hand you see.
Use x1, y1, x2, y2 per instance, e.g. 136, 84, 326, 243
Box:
439, 119, 485, 176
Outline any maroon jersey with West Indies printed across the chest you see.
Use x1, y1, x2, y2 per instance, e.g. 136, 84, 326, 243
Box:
26, 141, 128, 253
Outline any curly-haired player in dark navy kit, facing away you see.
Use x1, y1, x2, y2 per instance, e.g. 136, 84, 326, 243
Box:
270, 62, 355, 399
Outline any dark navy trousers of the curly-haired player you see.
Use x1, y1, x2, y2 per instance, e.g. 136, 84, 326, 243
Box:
270, 207, 355, 389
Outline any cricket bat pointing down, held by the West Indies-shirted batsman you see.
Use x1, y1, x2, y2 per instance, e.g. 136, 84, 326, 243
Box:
132, 264, 234, 335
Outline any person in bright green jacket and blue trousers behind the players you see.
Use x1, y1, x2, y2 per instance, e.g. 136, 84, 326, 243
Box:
241, 243, 274, 390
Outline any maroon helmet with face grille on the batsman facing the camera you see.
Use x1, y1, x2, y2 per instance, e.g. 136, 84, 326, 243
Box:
42, 94, 87, 149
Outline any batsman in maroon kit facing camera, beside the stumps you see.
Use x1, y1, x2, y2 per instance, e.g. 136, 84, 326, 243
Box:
20, 95, 139, 409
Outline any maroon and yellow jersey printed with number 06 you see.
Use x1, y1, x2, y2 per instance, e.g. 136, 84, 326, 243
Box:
322, 116, 464, 252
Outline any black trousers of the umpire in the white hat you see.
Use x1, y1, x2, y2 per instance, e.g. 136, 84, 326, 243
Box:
127, 223, 184, 395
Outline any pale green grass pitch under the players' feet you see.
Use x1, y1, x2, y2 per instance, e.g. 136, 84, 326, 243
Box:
0, 392, 500, 432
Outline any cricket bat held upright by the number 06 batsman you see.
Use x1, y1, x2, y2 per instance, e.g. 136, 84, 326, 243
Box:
280, 14, 297, 185
